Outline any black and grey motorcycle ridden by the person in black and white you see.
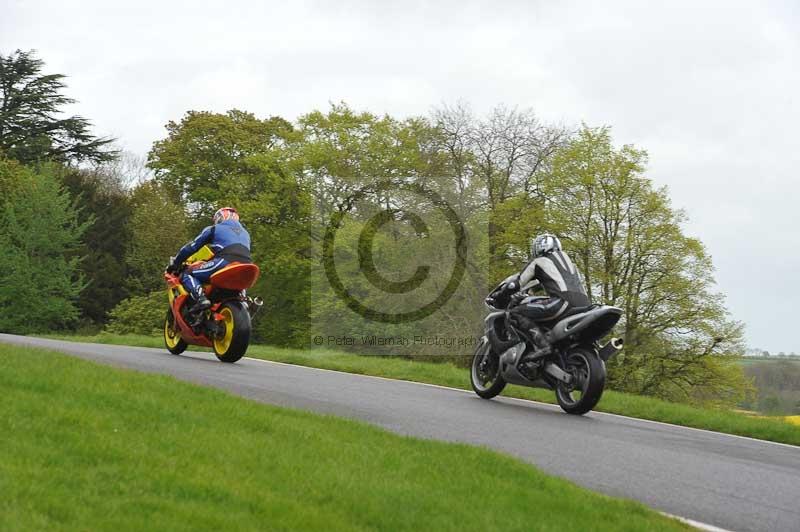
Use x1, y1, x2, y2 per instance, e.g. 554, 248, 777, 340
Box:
470, 275, 622, 415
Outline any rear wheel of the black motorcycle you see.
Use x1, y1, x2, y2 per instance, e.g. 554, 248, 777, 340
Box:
556, 347, 606, 415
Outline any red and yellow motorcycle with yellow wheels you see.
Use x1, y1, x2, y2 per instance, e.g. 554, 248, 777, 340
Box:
164, 261, 263, 362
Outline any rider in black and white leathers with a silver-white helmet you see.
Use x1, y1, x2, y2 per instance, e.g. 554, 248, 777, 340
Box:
498, 233, 591, 358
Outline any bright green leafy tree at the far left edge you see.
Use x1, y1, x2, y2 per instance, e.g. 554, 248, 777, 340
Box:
0, 160, 91, 334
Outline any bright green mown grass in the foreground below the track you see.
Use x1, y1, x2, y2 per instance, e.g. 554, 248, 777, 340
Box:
0, 345, 688, 532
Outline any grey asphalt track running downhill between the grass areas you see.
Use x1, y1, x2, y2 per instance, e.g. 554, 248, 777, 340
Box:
0, 334, 800, 531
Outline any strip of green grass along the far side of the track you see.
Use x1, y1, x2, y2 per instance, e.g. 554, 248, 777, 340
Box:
42, 333, 800, 445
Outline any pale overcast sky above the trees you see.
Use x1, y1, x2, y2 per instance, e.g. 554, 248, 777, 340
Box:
0, 0, 800, 352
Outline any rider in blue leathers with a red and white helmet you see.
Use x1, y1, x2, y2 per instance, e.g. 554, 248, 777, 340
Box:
167, 207, 252, 313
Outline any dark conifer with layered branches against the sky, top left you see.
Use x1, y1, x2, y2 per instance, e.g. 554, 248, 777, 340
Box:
0, 50, 116, 164
